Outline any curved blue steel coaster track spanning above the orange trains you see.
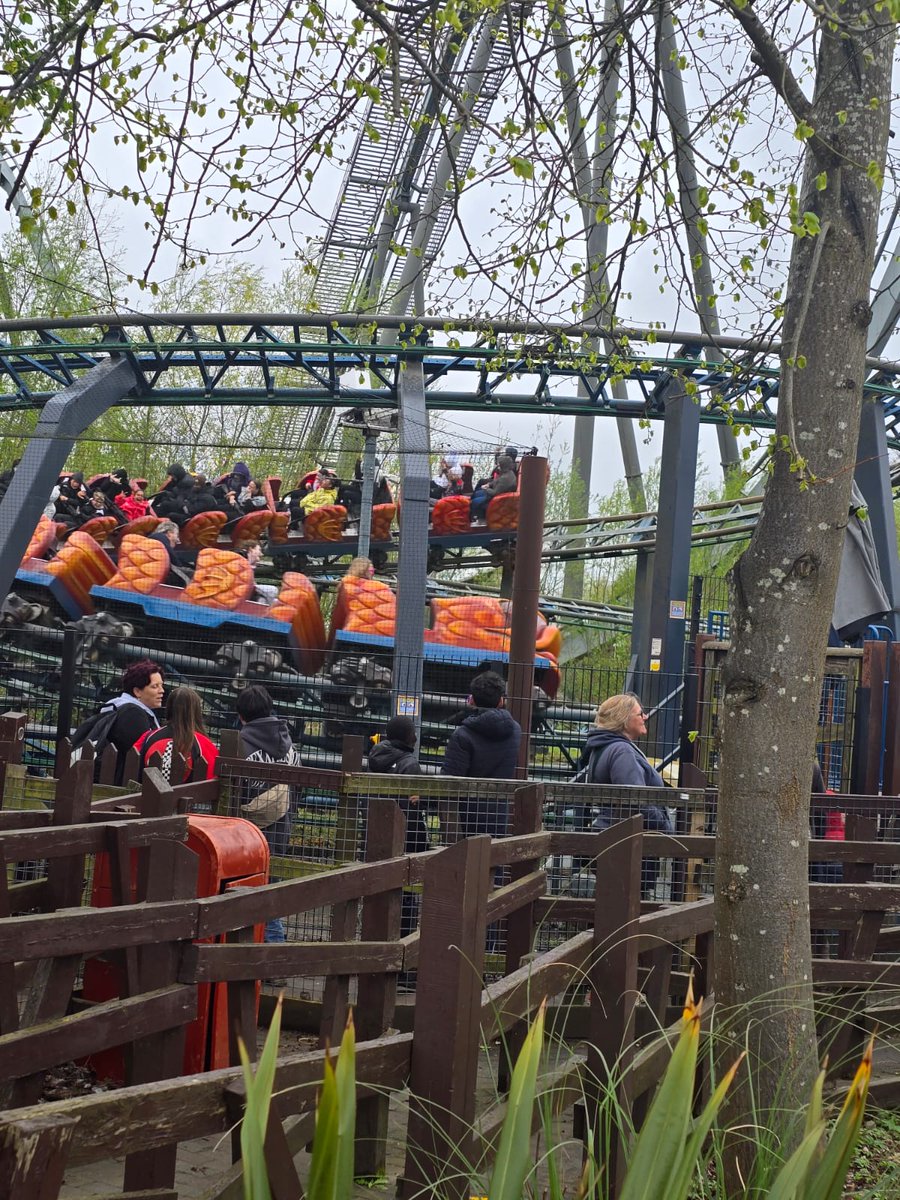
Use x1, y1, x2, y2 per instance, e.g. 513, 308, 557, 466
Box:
0, 313, 900, 449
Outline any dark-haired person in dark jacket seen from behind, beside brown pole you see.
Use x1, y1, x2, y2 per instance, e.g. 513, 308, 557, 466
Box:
440, 671, 522, 838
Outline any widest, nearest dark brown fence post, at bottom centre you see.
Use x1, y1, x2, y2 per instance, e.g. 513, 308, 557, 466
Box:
397, 835, 491, 1200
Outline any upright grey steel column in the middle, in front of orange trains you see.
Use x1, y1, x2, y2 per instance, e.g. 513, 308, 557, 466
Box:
391, 359, 431, 731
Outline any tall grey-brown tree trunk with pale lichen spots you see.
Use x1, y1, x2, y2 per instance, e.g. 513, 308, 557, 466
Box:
715, 0, 894, 1166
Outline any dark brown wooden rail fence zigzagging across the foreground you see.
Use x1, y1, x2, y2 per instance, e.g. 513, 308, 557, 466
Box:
0, 721, 900, 1200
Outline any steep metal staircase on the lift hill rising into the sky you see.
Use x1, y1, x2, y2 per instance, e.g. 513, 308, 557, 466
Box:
288, 2, 510, 457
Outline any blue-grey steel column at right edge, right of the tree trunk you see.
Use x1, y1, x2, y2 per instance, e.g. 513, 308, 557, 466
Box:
854, 400, 900, 640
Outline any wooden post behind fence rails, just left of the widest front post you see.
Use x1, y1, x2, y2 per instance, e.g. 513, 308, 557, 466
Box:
354, 796, 406, 1178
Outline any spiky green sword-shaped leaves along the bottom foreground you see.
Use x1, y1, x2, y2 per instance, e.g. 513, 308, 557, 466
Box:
241, 992, 872, 1200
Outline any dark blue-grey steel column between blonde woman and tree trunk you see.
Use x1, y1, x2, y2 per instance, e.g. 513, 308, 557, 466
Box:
641, 376, 700, 676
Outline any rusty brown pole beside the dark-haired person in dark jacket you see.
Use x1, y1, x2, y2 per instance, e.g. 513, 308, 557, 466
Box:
506, 455, 547, 779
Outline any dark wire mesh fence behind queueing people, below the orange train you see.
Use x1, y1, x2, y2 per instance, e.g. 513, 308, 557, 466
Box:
0, 625, 696, 779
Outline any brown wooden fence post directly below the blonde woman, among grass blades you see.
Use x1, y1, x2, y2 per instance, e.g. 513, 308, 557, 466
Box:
584, 816, 643, 1196
